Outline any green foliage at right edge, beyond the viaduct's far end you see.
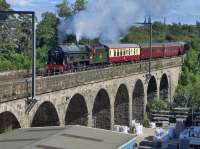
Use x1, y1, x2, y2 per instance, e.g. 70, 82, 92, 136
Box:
175, 39, 200, 111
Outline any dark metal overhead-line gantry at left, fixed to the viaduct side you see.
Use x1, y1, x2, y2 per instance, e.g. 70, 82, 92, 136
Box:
0, 10, 36, 112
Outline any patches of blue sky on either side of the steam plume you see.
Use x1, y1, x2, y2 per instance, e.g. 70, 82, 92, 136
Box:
7, 0, 200, 24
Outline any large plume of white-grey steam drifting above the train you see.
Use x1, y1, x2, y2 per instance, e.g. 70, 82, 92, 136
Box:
59, 0, 170, 43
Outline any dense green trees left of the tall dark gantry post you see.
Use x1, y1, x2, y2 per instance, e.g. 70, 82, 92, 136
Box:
0, 0, 32, 71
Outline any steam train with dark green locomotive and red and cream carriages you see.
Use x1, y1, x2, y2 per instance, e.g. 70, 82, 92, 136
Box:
45, 42, 188, 73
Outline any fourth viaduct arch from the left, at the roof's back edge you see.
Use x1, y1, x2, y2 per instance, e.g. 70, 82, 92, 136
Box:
92, 89, 111, 130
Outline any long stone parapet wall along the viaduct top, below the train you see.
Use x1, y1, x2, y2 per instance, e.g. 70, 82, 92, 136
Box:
0, 57, 182, 103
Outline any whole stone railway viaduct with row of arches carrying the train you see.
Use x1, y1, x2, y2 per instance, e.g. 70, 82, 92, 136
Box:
0, 57, 182, 132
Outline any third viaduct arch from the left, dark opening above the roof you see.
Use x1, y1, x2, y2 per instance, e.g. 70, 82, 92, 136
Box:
65, 94, 88, 126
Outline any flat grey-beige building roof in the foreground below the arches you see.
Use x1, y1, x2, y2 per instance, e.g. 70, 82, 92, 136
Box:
0, 125, 134, 149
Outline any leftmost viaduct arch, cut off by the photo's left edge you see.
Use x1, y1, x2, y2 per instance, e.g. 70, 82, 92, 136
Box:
0, 111, 21, 134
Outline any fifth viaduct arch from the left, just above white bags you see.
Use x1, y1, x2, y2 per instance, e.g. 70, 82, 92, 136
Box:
114, 84, 129, 126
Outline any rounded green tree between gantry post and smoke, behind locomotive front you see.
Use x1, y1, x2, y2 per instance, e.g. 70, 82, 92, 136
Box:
37, 12, 58, 48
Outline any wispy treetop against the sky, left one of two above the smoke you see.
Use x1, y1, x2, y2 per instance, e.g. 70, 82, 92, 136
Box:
56, 0, 73, 18
